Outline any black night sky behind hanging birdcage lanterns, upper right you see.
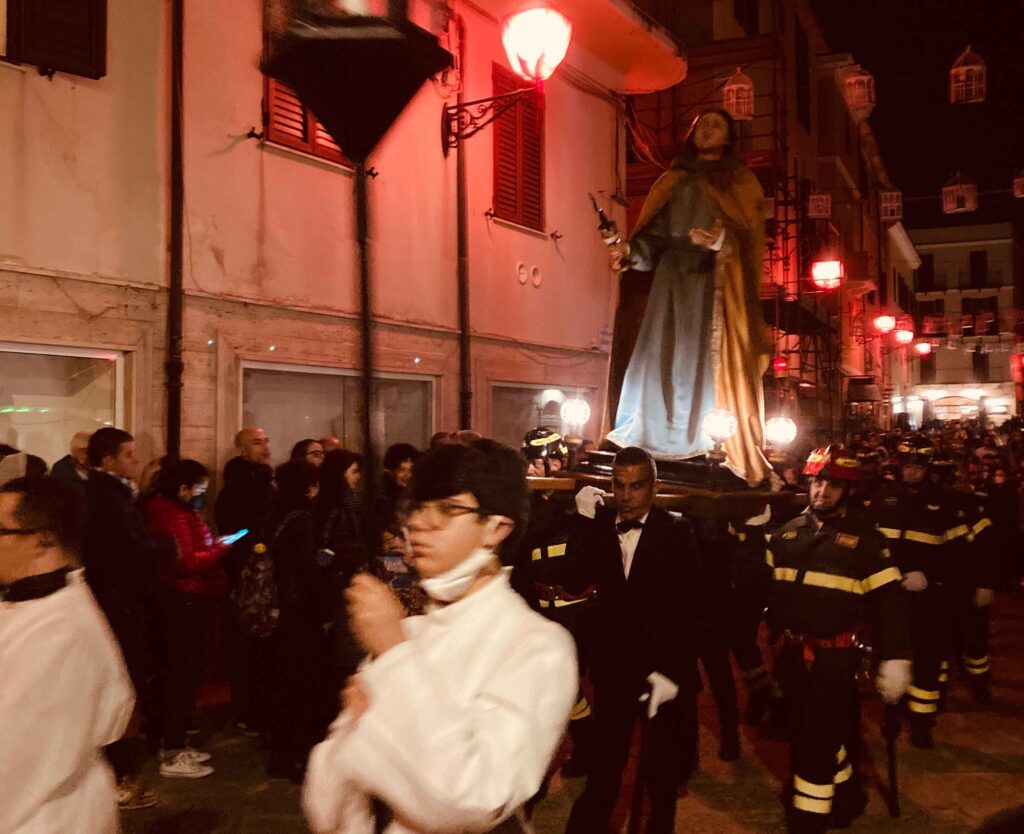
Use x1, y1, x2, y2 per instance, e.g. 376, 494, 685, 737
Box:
812, 0, 1024, 226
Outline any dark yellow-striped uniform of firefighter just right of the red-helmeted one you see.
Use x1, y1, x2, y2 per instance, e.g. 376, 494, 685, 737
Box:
870, 481, 971, 747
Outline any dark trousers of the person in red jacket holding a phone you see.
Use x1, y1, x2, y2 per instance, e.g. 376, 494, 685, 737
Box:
161, 588, 214, 750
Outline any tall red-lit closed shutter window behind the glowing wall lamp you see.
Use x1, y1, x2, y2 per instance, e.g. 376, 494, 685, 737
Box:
492, 64, 544, 232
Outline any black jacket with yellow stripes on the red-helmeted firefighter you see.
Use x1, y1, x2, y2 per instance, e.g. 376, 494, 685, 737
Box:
765, 510, 910, 660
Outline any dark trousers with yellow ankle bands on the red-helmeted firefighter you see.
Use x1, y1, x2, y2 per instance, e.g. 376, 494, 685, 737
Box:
777, 644, 860, 834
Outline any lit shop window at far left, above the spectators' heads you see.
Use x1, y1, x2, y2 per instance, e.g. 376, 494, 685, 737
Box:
0, 343, 124, 466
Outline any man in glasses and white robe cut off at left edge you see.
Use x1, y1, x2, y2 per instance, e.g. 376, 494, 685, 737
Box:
0, 477, 135, 834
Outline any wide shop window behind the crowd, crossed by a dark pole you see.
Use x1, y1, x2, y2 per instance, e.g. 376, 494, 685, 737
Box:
242, 363, 433, 463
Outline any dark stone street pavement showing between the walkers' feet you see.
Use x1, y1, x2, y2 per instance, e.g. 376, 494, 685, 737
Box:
122, 596, 1024, 834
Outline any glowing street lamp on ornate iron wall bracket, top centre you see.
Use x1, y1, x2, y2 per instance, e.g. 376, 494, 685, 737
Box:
441, 0, 572, 156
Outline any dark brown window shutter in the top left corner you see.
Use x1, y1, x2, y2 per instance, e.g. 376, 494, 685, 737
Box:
7, 0, 106, 79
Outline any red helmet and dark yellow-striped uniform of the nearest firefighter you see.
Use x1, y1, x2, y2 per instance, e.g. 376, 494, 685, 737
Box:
765, 447, 910, 832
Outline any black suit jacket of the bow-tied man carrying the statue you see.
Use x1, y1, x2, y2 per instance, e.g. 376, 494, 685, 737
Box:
567, 507, 708, 692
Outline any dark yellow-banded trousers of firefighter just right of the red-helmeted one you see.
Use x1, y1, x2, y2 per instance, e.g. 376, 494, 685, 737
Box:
907, 584, 953, 726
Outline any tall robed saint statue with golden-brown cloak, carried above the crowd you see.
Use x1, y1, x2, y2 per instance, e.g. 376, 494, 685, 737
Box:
606, 109, 771, 487
